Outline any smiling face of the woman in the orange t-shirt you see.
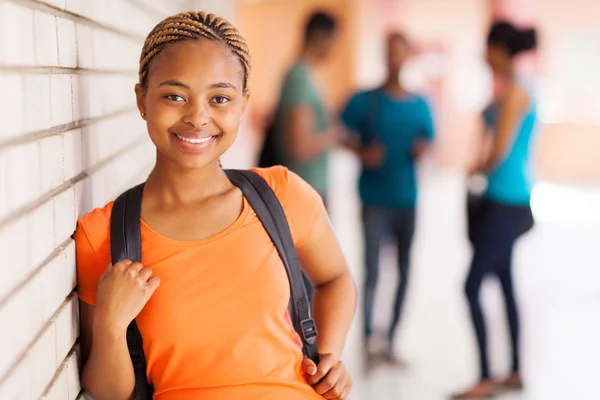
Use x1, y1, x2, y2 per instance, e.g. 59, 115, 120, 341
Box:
136, 39, 249, 169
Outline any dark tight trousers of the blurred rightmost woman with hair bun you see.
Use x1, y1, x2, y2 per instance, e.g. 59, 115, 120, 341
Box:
465, 199, 533, 379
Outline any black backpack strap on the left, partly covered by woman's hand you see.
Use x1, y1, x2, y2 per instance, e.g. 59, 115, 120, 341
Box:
110, 183, 154, 400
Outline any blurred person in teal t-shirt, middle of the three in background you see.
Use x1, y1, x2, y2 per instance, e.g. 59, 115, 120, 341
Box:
342, 32, 434, 363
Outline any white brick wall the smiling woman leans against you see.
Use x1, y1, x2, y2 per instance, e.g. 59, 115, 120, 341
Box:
0, 0, 244, 400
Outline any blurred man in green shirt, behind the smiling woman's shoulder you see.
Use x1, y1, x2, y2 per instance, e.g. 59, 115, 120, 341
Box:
274, 12, 342, 205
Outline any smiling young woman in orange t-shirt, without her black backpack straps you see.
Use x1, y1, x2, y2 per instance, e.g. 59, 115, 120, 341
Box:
75, 12, 355, 400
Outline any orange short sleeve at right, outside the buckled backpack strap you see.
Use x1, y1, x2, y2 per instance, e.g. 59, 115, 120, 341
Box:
255, 166, 325, 248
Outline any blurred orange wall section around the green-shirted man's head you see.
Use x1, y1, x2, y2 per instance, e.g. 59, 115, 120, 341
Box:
237, 0, 357, 132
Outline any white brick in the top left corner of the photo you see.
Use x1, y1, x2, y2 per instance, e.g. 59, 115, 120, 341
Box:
0, 2, 35, 65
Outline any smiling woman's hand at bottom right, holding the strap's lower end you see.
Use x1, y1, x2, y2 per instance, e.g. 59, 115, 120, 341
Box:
302, 354, 352, 400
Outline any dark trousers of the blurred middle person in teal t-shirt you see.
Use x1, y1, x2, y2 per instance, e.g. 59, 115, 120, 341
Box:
362, 206, 415, 344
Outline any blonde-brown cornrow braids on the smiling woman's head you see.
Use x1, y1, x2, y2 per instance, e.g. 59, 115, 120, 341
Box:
139, 11, 250, 88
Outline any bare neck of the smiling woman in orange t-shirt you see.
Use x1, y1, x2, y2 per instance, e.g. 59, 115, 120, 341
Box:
144, 155, 232, 204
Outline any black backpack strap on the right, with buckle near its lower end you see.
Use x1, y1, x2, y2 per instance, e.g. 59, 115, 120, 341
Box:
225, 170, 319, 365
